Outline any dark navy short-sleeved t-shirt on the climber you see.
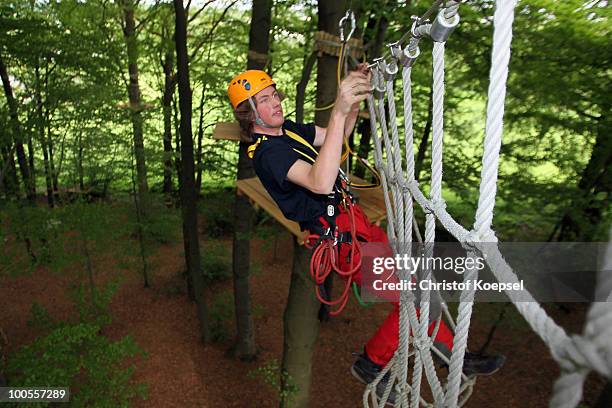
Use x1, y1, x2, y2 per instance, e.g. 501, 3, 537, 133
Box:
253, 120, 327, 229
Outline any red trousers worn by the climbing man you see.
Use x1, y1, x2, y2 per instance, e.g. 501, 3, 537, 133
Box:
320, 204, 453, 366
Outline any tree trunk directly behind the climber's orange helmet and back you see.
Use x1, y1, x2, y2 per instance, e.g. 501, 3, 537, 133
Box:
232, 0, 272, 360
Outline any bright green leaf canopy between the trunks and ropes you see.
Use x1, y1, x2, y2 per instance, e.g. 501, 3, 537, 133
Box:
0, 0, 612, 241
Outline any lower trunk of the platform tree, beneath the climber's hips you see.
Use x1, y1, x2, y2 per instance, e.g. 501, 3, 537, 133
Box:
280, 240, 319, 408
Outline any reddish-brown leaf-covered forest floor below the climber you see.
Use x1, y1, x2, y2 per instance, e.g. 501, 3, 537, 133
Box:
0, 206, 603, 408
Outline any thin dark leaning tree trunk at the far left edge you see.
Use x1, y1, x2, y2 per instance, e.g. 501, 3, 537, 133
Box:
0, 54, 36, 203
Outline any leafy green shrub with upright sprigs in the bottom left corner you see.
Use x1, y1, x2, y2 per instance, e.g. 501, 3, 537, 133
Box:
6, 282, 147, 407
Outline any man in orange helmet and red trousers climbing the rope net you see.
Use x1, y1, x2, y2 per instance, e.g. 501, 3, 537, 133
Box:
228, 64, 505, 403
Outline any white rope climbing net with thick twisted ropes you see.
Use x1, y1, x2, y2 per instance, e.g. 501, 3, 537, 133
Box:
363, 0, 612, 408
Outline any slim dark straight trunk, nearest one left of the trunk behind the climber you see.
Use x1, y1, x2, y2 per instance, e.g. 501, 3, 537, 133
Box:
174, 0, 210, 343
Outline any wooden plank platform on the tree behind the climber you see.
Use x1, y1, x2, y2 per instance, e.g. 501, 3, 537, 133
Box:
236, 176, 387, 244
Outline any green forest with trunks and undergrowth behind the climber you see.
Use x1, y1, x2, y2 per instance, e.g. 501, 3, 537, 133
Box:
0, 0, 612, 406
